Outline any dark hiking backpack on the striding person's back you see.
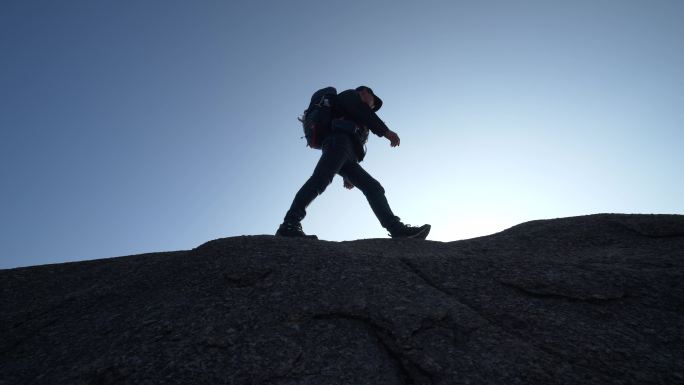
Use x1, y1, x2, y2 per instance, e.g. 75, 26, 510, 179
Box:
299, 87, 337, 150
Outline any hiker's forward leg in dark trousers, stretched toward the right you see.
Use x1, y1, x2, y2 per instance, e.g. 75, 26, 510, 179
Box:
338, 162, 400, 230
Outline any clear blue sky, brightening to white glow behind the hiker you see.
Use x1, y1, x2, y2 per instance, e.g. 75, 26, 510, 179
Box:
0, 0, 684, 268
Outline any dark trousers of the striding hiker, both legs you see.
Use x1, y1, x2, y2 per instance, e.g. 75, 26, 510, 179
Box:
285, 133, 399, 229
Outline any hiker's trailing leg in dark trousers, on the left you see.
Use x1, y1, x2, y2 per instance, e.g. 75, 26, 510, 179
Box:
285, 134, 353, 223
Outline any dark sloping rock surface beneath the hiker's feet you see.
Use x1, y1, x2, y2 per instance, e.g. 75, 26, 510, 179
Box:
0, 215, 684, 385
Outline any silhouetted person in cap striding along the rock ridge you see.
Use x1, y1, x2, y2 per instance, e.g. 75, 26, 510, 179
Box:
276, 86, 430, 239
